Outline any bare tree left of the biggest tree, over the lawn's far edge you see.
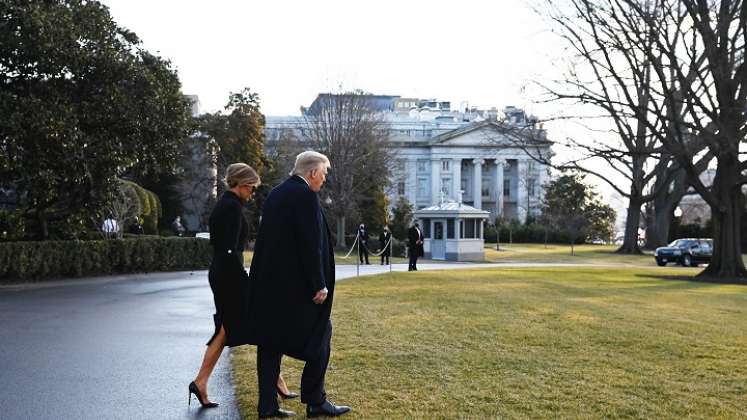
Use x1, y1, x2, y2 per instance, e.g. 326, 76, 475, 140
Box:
530, 0, 712, 253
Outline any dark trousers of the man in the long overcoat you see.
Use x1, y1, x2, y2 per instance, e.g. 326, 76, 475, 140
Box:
257, 321, 332, 413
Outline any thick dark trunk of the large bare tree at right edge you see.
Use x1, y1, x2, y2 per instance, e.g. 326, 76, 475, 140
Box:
698, 162, 747, 283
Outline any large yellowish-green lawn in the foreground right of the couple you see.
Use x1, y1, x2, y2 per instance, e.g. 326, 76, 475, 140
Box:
233, 267, 747, 419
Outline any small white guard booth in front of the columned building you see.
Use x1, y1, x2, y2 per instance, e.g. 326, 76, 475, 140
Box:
414, 201, 490, 261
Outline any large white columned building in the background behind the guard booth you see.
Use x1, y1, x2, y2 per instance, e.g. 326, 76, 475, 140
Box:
265, 94, 552, 222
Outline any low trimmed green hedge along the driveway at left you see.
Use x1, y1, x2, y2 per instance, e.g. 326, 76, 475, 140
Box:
0, 237, 212, 282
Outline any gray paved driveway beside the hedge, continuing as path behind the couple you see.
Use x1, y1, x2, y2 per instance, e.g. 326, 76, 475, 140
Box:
0, 262, 612, 420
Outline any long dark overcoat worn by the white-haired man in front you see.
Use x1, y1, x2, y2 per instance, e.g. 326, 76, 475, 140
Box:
246, 176, 335, 361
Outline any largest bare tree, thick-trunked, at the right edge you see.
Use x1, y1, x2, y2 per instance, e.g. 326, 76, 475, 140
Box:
620, 0, 747, 282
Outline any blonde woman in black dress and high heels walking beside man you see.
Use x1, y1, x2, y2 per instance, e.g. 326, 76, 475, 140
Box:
189, 163, 298, 408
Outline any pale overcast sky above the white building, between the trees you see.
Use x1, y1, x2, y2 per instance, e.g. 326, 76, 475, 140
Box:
104, 0, 564, 115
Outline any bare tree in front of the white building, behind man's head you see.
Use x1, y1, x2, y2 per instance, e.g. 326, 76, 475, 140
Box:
301, 91, 391, 247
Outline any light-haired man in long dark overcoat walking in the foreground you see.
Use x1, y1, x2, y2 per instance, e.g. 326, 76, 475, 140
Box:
247, 151, 350, 418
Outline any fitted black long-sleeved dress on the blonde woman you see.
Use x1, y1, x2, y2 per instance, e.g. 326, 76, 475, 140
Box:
208, 191, 249, 346
